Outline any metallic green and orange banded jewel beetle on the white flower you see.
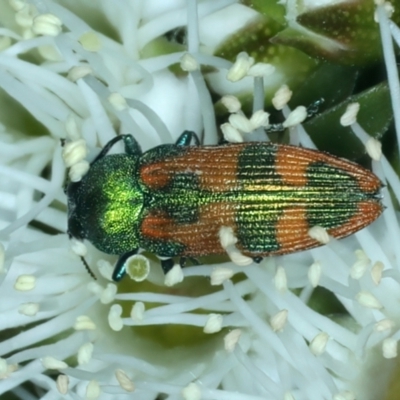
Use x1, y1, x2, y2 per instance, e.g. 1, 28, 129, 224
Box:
66, 131, 383, 281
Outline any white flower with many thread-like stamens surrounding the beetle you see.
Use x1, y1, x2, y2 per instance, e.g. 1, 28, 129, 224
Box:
0, 0, 400, 400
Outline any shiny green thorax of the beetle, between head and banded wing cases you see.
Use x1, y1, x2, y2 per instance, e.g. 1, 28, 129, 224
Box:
75, 154, 143, 254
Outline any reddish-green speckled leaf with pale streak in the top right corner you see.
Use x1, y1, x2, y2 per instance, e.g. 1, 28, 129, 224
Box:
272, 0, 382, 65
